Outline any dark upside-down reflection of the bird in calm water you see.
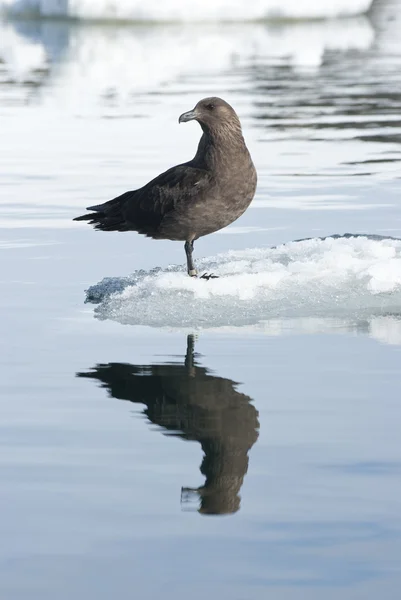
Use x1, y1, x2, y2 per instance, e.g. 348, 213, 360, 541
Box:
77, 335, 259, 515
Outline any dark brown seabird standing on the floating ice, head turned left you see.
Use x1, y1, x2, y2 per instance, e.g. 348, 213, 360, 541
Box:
74, 98, 257, 278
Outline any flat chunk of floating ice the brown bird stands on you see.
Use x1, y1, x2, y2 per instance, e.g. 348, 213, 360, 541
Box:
87, 236, 401, 328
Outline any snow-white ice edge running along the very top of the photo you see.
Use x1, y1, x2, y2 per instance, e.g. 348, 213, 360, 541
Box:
0, 0, 372, 21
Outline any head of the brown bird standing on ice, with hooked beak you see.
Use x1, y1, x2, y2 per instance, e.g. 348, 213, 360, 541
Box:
178, 97, 241, 130
